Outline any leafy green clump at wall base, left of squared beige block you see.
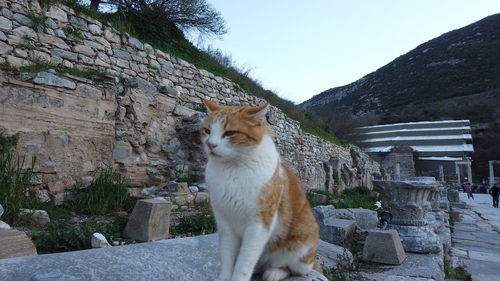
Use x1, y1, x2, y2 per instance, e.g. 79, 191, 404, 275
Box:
72, 168, 130, 215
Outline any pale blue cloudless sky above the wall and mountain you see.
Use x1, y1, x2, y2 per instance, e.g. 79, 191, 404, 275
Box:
201, 0, 500, 103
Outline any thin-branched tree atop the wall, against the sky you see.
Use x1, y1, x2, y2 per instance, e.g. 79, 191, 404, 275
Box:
108, 0, 227, 35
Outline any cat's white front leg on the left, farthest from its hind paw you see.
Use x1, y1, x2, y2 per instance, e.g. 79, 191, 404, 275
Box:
216, 219, 241, 281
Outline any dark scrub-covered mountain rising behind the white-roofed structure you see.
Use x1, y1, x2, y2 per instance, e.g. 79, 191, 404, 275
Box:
301, 14, 500, 177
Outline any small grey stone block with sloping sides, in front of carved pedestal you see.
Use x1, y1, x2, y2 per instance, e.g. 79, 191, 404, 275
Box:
363, 229, 406, 264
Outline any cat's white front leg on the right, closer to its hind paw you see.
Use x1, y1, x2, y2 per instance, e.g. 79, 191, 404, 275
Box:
231, 223, 271, 281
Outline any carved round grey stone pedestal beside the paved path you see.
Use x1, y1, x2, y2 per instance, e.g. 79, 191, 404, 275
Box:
374, 177, 443, 254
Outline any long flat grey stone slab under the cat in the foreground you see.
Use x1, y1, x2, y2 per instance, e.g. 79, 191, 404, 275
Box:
0, 234, 328, 281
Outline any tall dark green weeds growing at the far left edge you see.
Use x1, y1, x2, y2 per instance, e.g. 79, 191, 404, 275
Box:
0, 133, 36, 225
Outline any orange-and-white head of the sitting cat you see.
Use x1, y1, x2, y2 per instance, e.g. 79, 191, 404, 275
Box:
200, 100, 269, 159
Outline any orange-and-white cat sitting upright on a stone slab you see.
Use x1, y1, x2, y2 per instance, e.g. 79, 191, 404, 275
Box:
200, 100, 320, 281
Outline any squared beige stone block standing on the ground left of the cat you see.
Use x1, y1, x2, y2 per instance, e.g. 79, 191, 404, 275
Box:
123, 198, 172, 241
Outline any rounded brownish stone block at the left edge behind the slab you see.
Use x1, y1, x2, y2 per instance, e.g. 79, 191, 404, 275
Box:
0, 229, 37, 259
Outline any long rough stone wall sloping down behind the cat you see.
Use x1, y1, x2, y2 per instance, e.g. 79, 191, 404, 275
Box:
0, 0, 379, 202
